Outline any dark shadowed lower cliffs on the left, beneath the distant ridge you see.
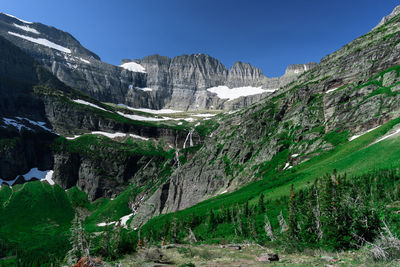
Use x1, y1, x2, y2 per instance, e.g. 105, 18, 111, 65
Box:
0, 34, 198, 200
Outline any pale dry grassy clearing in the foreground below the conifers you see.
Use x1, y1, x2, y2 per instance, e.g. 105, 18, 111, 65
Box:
110, 244, 400, 267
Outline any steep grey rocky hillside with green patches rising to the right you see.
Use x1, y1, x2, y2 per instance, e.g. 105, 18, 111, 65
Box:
130, 4, 400, 226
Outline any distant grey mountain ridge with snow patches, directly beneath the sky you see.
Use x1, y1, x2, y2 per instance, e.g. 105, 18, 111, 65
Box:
0, 13, 316, 111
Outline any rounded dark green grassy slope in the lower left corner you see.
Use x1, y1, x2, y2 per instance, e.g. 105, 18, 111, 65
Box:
0, 181, 74, 262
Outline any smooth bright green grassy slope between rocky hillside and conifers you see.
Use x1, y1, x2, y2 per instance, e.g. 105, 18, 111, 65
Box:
143, 118, 400, 238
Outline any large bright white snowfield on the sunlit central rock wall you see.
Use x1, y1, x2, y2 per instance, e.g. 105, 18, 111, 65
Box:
207, 85, 276, 101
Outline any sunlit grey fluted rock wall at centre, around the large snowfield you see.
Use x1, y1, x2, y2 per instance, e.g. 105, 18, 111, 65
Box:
135, 54, 315, 110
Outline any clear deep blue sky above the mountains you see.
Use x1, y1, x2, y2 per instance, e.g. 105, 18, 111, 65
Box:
0, 0, 400, 77
